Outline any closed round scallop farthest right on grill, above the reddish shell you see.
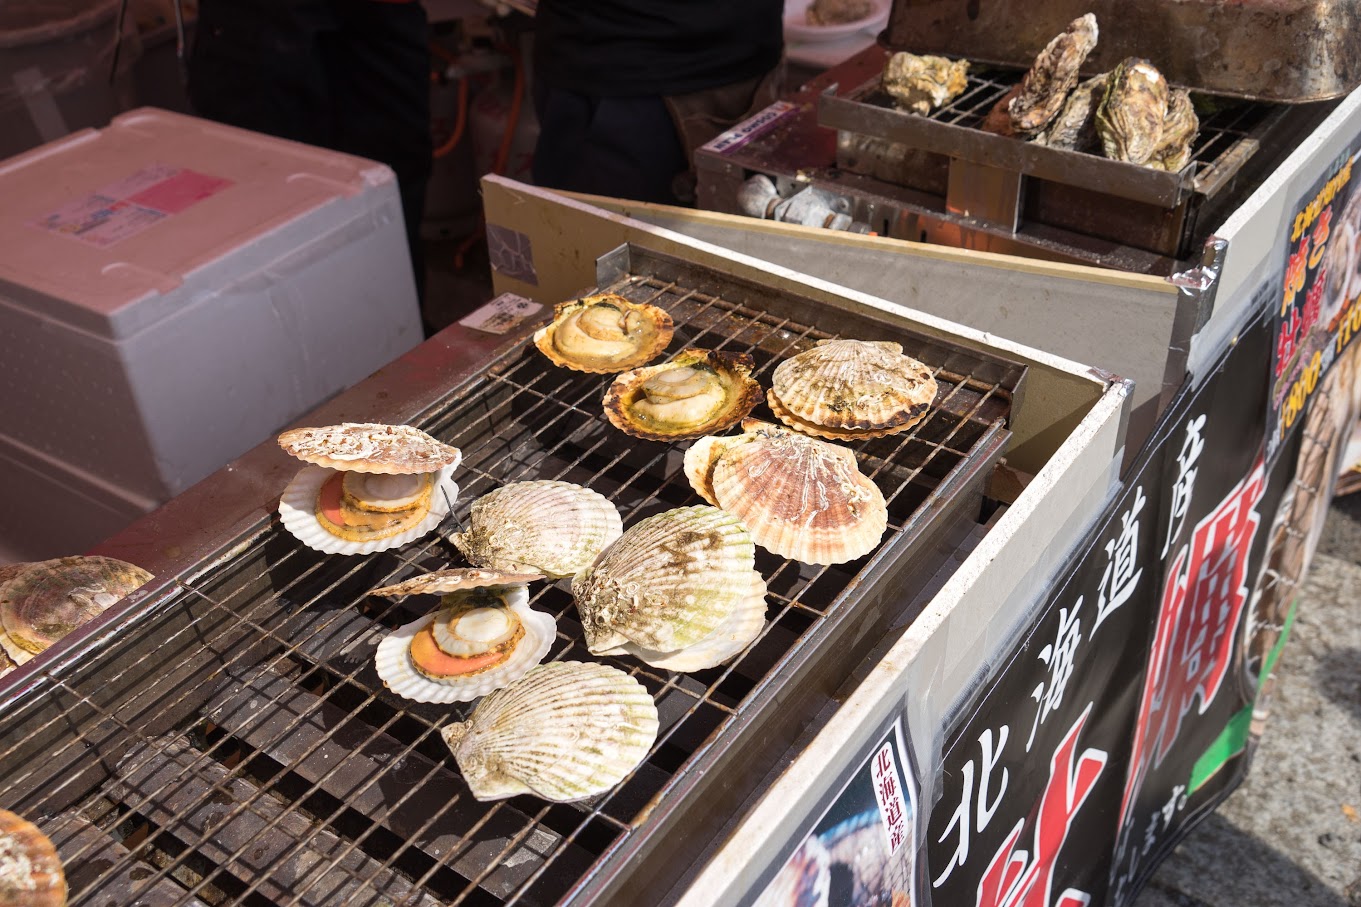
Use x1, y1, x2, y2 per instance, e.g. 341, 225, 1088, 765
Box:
770, 340, 936, 432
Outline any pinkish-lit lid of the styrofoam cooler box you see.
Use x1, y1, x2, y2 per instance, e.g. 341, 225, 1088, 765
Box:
0, 108, 392, 334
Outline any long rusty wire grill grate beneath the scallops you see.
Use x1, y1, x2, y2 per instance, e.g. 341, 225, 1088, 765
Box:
0, 246, 1025, 907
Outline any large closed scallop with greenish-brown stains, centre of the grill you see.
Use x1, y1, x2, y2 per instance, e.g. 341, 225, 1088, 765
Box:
572, 505, 765, 670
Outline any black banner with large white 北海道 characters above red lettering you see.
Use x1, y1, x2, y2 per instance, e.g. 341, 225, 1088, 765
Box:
920, 439, 1164, 907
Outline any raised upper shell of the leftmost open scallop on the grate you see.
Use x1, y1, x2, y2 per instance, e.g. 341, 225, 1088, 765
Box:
279, 422, 463, 474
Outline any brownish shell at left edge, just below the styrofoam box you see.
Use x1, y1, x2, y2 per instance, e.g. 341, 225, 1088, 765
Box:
0, 557, 151, 661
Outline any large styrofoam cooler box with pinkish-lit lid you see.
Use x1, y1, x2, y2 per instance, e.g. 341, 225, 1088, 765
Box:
0, 109, 422, 558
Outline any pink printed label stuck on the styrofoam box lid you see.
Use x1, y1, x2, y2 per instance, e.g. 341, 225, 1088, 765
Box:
29, 163, 233, 248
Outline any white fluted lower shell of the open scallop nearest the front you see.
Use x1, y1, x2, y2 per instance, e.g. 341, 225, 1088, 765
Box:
374, 596, 558, 703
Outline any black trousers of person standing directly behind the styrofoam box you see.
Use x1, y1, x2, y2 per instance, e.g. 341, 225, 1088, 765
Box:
189, 0, 433, 289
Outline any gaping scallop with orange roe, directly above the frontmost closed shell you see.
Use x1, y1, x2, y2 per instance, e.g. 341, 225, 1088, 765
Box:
373, 569, 557, 703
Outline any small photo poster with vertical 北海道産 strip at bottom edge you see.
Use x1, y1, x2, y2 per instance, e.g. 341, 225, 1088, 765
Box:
749, 718, 917, 907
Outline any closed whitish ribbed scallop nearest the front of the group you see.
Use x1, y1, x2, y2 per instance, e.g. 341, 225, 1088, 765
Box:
440, 662, 659, 802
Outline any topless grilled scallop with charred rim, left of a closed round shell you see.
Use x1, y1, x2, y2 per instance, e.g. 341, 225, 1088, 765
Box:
604, 350, 761, 441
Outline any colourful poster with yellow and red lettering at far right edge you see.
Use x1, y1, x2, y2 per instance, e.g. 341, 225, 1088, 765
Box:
1267, 140, 1361, 462
